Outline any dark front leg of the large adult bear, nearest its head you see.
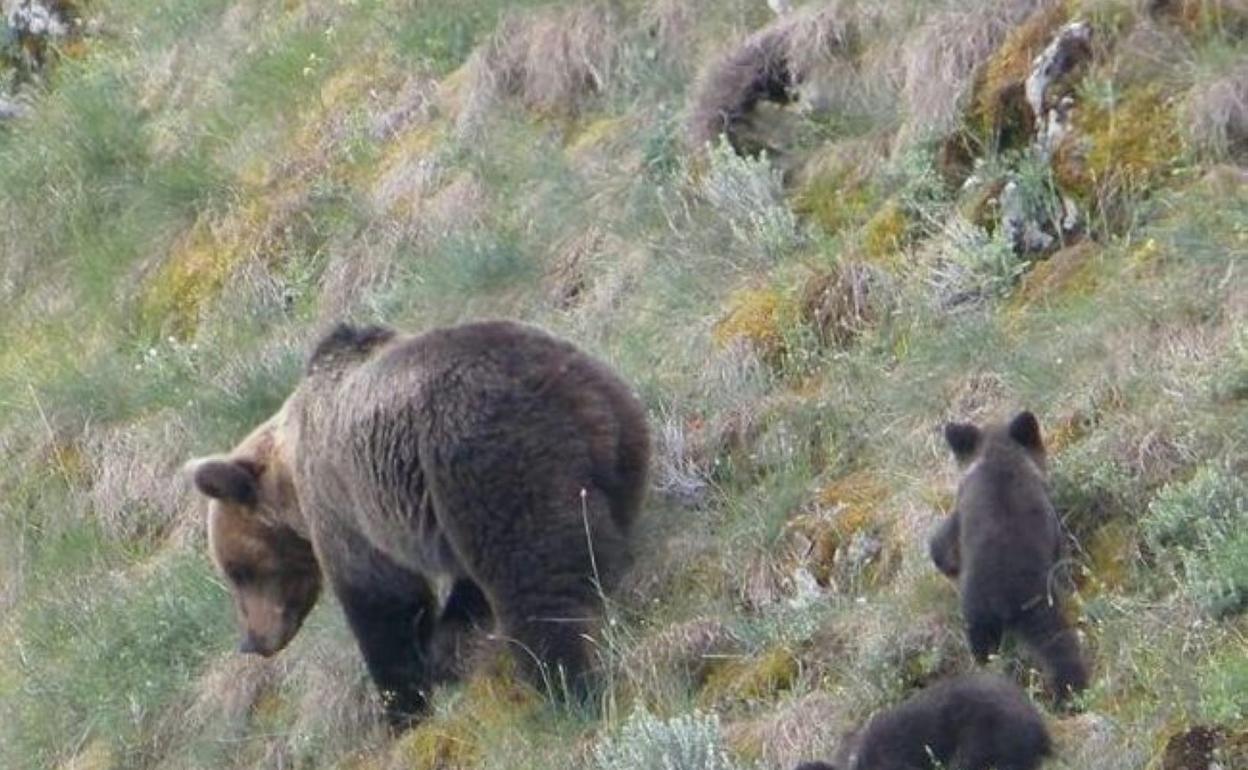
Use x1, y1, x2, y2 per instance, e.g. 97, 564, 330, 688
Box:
329, 552, 437, 729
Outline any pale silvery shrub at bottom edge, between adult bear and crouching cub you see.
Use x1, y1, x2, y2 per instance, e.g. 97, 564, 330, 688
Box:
594, 710, 738, 770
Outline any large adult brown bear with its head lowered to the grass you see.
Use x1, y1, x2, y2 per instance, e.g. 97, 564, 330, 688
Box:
188, 322, 650, 724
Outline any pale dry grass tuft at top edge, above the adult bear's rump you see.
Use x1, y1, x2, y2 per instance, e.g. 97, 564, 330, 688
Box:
459, 2, 620, 130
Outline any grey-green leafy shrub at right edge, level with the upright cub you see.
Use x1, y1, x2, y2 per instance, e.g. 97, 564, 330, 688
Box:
1142, 467, 1248, 616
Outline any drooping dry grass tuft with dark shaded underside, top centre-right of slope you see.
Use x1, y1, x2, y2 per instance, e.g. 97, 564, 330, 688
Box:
688, 2, 857, 152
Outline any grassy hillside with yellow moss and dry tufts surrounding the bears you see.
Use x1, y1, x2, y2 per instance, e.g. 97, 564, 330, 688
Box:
0, 0, 1248, 770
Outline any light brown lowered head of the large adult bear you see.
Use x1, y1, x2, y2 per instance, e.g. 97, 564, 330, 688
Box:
186, 409, 321, 658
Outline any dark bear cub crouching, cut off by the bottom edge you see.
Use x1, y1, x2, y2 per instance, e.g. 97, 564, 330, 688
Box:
797, 674, 1052, 770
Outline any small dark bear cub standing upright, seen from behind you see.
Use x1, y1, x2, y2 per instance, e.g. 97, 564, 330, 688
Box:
929, 412, 1088, 700
